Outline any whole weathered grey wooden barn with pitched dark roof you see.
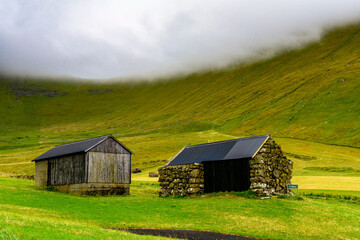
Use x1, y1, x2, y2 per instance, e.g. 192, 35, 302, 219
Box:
32, 135, 133, 194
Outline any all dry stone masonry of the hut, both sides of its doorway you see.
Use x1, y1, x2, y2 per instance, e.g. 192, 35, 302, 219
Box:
159, 137, 293, 196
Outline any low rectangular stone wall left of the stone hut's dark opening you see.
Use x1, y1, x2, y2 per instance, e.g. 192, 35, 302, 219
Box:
159, 163, 204, 196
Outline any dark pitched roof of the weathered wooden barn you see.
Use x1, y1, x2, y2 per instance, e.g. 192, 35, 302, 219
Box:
32, 135, 133, 161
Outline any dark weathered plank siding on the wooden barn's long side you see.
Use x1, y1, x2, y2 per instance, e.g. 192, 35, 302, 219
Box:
48, 154, 86, 185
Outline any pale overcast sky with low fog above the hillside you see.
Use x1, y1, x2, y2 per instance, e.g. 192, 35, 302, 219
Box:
0, 0, 360, 79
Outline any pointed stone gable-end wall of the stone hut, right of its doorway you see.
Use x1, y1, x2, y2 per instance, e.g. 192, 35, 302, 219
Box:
250, 138, 293, 196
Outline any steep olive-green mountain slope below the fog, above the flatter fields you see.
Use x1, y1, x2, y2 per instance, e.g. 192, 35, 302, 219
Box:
1, 23, 360, 146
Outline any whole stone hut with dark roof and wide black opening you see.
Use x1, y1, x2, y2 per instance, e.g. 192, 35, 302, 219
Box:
159, 135, 293, 196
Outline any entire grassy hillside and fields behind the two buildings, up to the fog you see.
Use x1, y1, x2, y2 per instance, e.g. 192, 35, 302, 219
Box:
0, 25, 360, 176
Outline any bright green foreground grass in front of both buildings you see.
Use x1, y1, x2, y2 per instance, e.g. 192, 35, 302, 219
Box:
0, 178, 360, 239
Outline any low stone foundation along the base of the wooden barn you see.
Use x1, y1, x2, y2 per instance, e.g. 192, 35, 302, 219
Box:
53, 183, 130, 195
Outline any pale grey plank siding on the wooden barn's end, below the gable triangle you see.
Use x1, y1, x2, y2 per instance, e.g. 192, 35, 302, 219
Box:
87, 151, 131, 183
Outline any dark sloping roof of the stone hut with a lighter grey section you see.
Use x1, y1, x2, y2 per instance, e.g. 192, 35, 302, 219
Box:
168, 135, 270, 166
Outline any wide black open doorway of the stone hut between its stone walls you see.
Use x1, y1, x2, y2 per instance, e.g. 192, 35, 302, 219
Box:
203, 159, 250, 193
